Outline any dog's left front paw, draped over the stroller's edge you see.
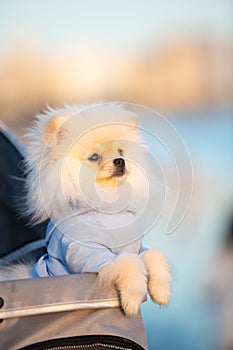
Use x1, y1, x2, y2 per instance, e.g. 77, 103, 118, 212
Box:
99, 253, 147, 316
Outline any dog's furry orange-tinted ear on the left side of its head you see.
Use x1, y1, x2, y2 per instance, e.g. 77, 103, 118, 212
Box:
44, 114, 68, 146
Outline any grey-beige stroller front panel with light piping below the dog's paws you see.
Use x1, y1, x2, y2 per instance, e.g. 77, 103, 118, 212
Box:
0, 273, 147, 350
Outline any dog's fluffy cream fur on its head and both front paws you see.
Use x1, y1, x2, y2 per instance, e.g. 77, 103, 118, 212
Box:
0, 103, 171, 316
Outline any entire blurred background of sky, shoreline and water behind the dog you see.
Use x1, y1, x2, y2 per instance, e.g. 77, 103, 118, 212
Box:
0, 0, 233, 350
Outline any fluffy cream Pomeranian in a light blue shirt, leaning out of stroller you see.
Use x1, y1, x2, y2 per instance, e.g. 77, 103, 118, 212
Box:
0, 103, 171, 316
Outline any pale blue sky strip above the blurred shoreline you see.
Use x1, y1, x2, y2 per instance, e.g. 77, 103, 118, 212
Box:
0, 0, 233, 54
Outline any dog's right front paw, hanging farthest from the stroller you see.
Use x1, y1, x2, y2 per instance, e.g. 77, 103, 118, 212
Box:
142, 249, 171, 305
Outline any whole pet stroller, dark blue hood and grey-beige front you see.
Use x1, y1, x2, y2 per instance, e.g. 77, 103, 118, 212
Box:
0, 122, 147, 350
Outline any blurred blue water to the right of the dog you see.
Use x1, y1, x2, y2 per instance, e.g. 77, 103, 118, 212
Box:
142, 110, 233, 350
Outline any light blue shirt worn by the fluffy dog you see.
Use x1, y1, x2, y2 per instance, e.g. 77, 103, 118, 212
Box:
31, 211, 145, 278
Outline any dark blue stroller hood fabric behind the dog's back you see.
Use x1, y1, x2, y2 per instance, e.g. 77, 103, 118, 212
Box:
0, 121, 46, 263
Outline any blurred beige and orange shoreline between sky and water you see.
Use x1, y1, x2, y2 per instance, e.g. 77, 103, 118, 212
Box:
0, 38, 233, 137
